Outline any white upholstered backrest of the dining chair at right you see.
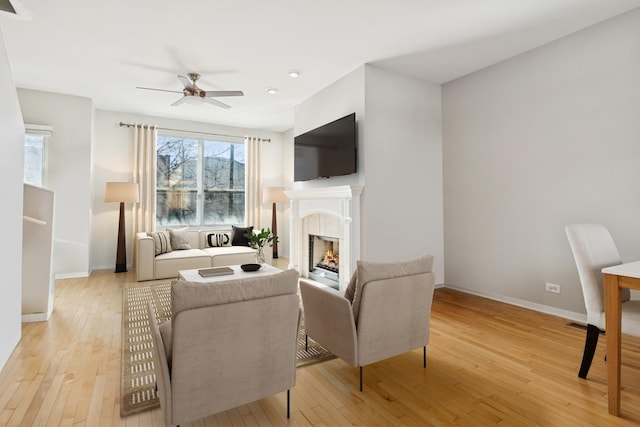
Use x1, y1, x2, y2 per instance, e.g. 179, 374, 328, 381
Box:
565, 224, 630, 327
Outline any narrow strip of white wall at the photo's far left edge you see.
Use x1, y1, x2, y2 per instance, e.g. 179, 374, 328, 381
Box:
0, 27, 24, 370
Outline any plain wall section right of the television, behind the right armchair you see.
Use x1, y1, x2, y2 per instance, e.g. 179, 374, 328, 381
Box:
361, 65, 444, 283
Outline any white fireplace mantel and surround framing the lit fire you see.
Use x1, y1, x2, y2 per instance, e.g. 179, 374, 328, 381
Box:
285, 185, 362, 290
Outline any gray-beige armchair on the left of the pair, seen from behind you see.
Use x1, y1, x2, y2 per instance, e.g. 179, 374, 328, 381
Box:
149, 270, 300, 425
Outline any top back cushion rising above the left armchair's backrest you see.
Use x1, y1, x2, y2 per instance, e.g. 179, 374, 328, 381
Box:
171, 269, 298, 319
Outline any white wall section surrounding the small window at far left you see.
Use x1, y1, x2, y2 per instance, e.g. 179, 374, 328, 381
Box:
18, 89, 93, 277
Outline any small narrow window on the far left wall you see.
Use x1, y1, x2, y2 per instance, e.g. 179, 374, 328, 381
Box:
24, 125, 51, 187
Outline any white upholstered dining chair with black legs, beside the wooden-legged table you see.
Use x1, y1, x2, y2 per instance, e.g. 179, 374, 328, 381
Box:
565, 224, 640, 379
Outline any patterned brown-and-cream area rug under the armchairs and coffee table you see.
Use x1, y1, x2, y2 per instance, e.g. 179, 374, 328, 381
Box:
120, 282, 335, 417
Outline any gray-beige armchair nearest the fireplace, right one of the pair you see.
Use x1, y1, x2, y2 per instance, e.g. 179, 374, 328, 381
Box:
300, 255, 435, 391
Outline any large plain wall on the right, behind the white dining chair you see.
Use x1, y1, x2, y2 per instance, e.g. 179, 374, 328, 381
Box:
443, 6, 640, 313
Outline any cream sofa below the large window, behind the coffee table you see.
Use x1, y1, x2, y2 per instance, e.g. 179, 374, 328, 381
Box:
134, 228, 273, 281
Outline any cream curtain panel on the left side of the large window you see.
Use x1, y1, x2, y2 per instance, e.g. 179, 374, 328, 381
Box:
133, 124, 158, 236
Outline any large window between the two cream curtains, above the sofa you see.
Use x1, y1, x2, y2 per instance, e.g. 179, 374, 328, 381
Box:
156, 134, 245, 227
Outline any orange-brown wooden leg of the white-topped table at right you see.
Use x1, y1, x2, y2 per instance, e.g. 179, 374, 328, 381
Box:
604, 274, 622, 416
